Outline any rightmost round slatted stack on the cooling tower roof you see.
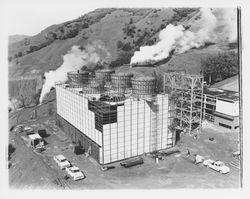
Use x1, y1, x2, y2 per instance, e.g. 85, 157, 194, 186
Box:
131, 77, 156, 98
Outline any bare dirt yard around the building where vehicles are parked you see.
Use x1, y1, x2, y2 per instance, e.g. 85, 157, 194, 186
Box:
9, 112, 240, 189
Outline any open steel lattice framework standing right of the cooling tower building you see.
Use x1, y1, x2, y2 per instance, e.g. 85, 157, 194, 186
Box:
164, 72, 203, 135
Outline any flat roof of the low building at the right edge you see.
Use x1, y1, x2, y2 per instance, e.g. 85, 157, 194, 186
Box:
203, 88, 239, 101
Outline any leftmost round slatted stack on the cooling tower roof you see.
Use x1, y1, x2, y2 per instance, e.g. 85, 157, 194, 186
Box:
67, 71, 89, 88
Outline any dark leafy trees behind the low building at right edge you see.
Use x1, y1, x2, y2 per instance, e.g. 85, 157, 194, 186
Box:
201, 52, 239, 84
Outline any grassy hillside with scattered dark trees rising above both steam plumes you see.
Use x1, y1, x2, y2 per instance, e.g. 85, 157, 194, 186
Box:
9, 8, 203, 78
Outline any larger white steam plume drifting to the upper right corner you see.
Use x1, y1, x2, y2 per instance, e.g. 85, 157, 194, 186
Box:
130, 8, 237, 64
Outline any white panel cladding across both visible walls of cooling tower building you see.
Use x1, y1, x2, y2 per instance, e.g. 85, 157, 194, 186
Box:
56, 85, 174, 164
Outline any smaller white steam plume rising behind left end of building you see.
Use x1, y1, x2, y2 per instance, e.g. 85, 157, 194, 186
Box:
39, 42, 110, 103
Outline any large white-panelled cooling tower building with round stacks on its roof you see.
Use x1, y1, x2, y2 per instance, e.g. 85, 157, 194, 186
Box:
55, 69, 175, 164
